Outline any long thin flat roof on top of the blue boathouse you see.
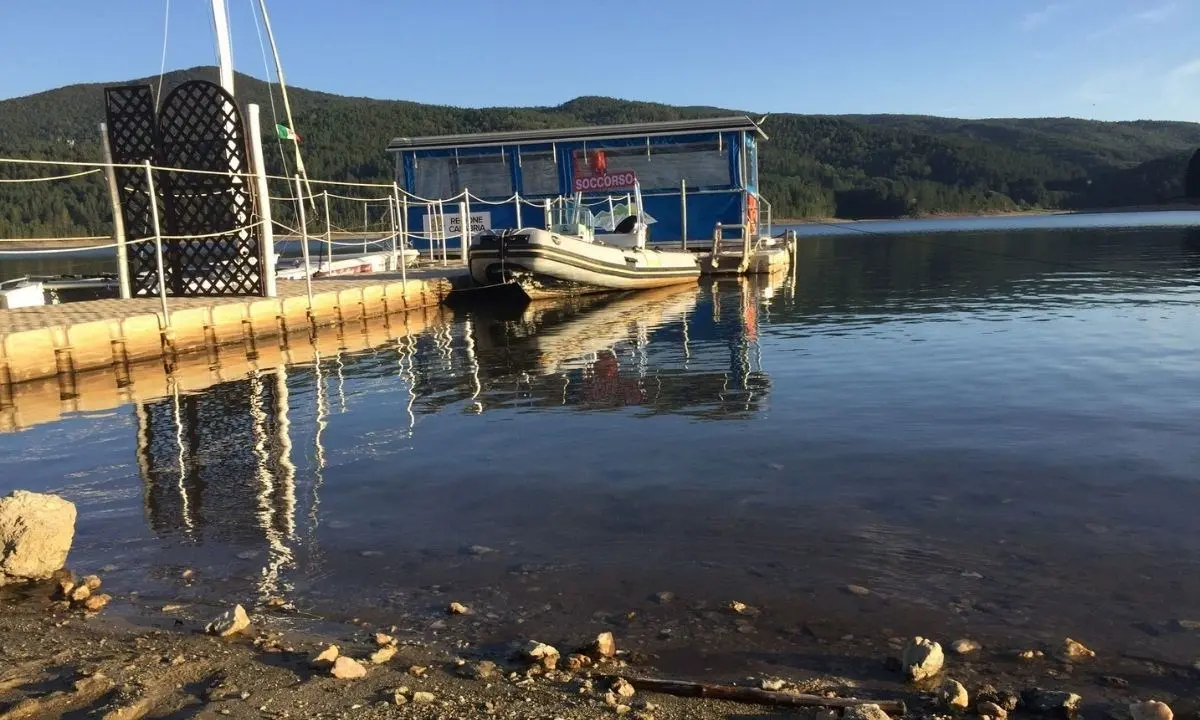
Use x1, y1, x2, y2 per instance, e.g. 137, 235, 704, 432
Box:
388, 115, 767, 152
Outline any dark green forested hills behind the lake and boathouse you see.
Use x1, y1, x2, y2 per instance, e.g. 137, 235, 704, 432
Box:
0, 67, 1200, 236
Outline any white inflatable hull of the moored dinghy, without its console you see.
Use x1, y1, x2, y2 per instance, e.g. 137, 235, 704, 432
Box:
468, 229, 700, 300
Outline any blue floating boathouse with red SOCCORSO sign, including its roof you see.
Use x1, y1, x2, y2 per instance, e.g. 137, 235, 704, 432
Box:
388, 115, 770, 242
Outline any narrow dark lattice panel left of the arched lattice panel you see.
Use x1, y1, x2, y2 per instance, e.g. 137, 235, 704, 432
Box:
104, 85, 158, 295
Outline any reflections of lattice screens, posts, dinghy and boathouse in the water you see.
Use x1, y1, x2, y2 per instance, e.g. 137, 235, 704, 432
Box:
124, 277, 785, 600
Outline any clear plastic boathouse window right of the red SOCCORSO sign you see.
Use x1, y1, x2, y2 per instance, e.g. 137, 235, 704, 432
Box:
589, 140, 731, 190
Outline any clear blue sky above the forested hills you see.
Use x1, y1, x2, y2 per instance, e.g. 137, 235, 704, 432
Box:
0, 0, 1200, 120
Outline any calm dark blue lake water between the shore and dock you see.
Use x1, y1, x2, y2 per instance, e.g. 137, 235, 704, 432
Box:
0, 216, 1200, 665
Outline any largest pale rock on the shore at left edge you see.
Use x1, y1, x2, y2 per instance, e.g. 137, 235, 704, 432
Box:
0, 490, 76, 586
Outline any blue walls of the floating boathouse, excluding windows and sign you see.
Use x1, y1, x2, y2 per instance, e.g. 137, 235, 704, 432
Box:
396, 131, 758, 250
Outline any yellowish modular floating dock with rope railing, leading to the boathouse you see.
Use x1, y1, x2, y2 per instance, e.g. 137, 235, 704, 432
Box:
0, 268, 468, 388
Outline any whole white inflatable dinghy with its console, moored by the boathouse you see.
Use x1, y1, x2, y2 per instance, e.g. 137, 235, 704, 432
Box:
467, 187, 700, 300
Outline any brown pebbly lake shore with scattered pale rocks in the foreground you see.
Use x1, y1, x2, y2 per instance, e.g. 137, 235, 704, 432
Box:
0, 493, 1200, 720
